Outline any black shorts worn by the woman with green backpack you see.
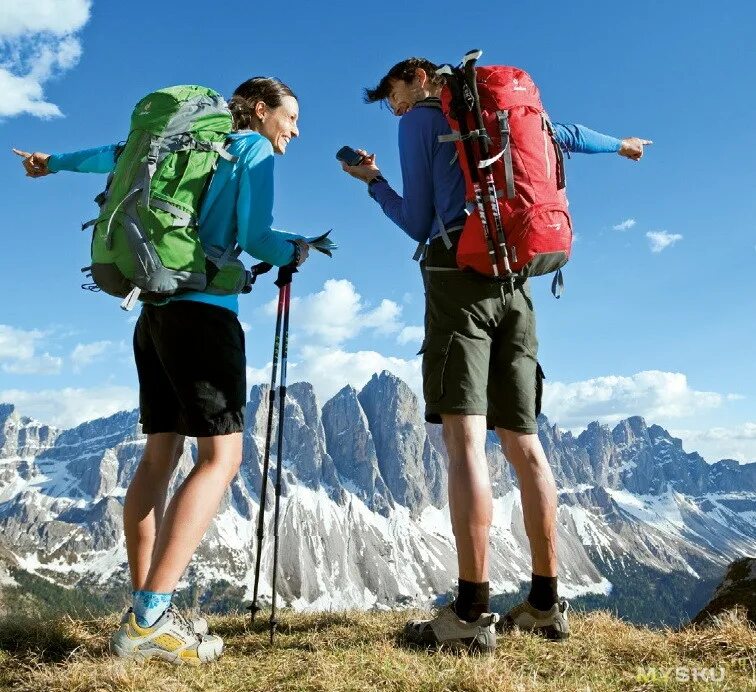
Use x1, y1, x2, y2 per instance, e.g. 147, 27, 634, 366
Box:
134, 300, 247, 437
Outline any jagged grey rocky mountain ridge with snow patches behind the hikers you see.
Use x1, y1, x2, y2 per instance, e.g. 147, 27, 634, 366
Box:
0, 371, 756, 628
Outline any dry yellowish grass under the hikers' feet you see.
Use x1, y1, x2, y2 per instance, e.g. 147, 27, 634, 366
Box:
0, 612, 756, 692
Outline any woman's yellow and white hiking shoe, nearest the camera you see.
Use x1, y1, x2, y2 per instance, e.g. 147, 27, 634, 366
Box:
110, 606, 223, 665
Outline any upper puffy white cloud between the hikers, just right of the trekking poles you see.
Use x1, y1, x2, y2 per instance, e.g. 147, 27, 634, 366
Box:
265, 279, 403, 346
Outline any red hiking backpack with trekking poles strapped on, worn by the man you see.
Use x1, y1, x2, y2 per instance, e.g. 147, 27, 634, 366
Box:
439, 51, 572, 297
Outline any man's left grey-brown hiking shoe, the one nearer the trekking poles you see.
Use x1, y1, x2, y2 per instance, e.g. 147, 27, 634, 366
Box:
403, 603, 499, 654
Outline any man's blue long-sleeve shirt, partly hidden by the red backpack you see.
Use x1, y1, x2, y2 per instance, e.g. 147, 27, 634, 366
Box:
369, 101, 622, 243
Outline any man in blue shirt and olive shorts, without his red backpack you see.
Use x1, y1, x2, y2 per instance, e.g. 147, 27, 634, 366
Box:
342, 58, 651, 651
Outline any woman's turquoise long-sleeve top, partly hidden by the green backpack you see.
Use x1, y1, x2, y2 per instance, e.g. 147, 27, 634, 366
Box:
47, 132, 301, 314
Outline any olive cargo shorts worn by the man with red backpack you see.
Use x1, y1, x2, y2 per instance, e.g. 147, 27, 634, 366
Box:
420, 240, 543, 433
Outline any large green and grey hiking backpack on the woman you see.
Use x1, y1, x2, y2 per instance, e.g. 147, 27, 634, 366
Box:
82, 85, 252, 310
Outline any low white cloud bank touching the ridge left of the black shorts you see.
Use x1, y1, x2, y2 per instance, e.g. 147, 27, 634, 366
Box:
0, 386, 138, 428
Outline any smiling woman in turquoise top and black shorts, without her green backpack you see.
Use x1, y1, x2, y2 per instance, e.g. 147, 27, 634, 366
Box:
14, 77, 309, 665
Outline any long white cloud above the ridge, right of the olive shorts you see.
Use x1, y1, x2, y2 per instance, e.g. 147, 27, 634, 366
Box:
543, 370, 726, 428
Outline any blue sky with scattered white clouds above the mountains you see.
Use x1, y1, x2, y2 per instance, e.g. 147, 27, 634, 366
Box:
0, 0, 756, 461
